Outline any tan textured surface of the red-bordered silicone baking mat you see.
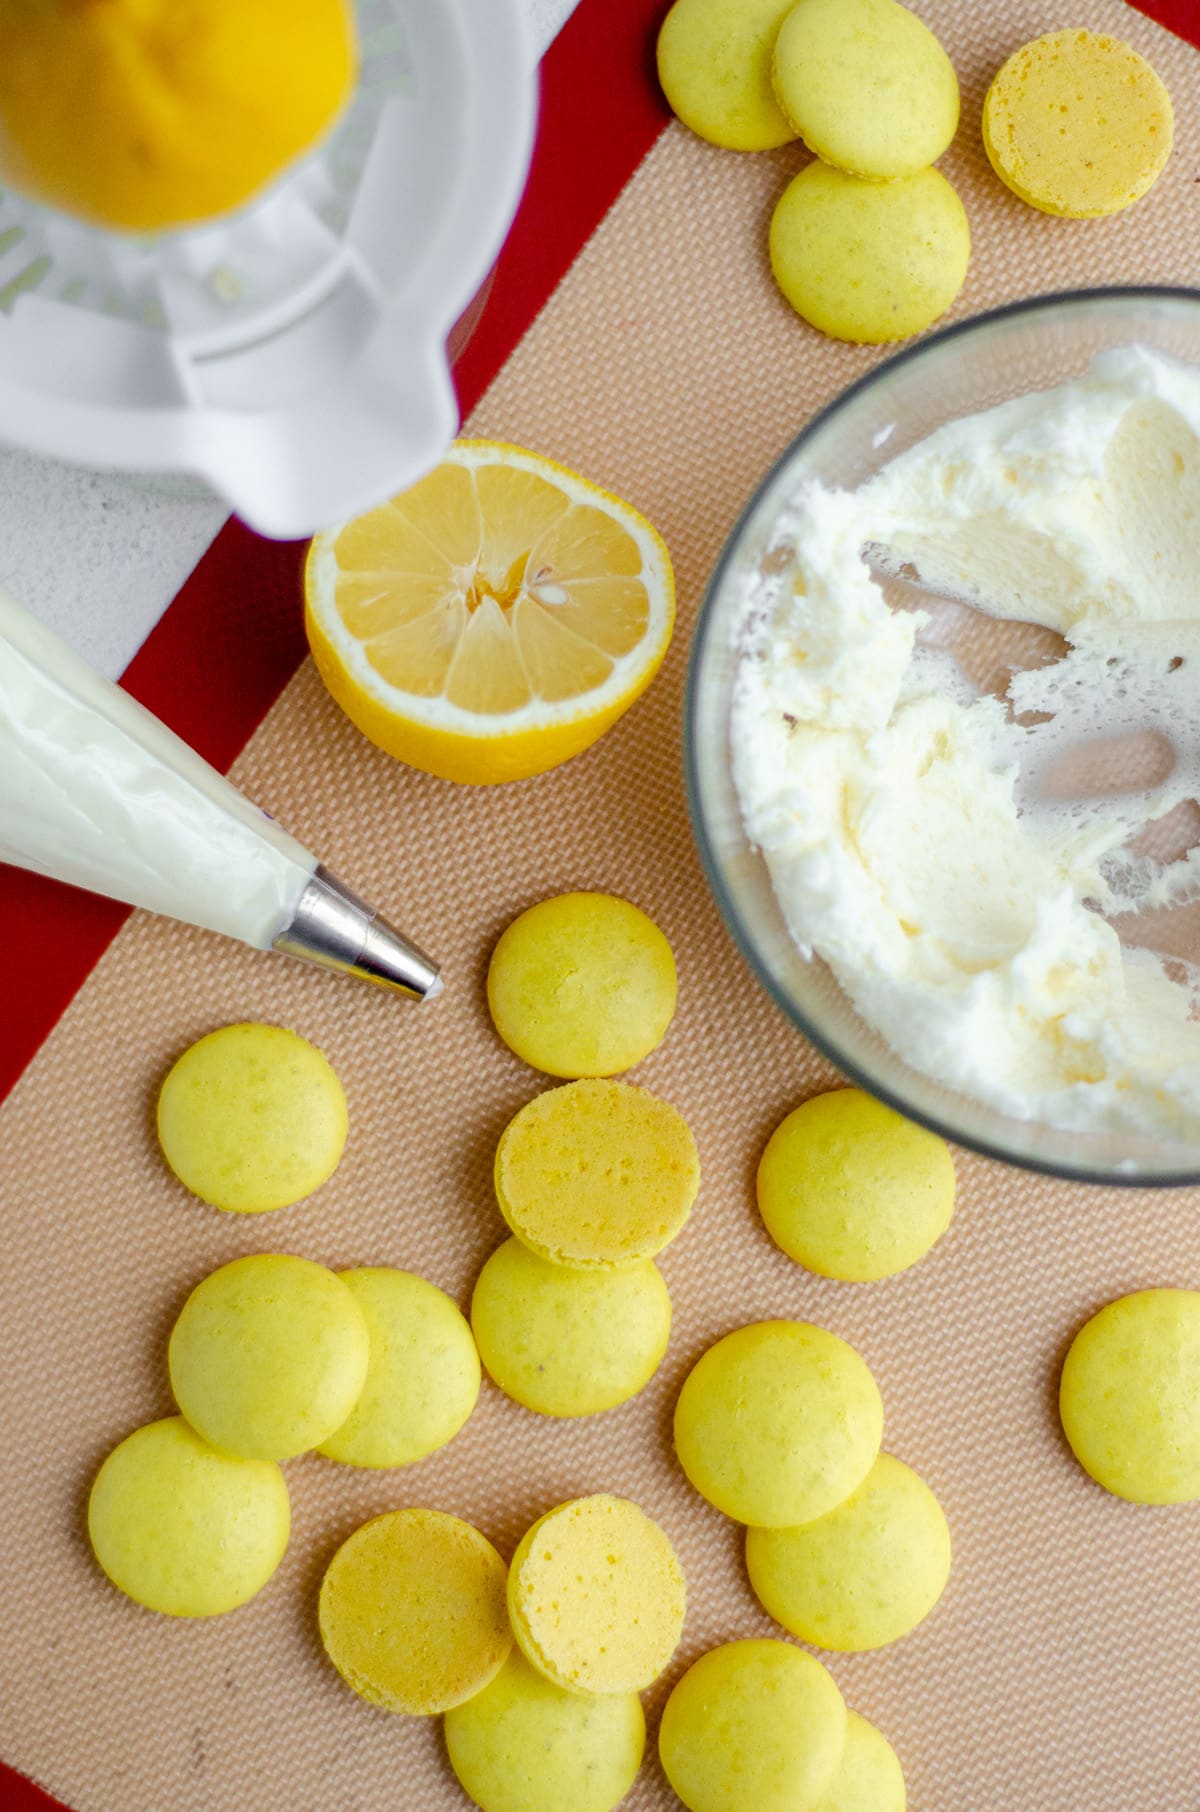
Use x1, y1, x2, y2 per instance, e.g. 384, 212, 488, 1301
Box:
0, 0, 1200, 1812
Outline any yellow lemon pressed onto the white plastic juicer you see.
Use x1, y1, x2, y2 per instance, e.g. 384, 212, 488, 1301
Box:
0, 0, 357, 232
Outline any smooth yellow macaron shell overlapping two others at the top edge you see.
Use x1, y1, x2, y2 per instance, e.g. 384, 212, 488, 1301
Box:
772, 0, 959, 181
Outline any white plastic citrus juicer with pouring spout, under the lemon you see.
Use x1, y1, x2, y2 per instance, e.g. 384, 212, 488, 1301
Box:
0, 0, 537, 538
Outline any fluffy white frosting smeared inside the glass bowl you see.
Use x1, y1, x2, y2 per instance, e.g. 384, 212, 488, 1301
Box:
731, 348, 1200, 1136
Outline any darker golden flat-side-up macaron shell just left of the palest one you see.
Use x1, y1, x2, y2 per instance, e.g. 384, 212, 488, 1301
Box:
319, 1509, 513, 1718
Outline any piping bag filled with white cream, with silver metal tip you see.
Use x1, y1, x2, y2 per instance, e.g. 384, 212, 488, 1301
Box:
0, 591, 442, 1000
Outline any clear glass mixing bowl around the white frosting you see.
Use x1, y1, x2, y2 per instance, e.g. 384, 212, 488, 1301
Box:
685, 288, 1200, 1183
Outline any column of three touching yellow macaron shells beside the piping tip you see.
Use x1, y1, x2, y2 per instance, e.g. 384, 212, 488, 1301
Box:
471, 893, 700, 1417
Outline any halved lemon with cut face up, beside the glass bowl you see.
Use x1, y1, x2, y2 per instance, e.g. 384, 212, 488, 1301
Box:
305, 440, 674, 785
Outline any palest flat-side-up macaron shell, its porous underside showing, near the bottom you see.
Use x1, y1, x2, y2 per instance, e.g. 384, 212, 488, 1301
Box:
508, 1495, 687, 1692
